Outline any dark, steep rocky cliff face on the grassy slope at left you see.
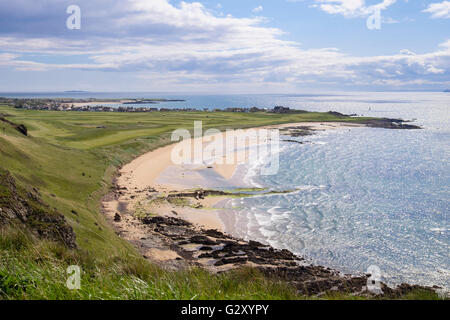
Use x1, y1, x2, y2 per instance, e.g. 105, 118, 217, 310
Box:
0, 168, 76, 248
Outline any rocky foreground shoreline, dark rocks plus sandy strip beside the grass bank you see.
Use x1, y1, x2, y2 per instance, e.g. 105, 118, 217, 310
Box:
104, 181, 434, 298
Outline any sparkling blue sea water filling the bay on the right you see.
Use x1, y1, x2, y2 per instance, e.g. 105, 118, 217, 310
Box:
220, 93, 450, 291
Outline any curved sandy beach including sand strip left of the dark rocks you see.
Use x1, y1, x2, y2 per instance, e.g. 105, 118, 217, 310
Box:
102, 122, 370, 271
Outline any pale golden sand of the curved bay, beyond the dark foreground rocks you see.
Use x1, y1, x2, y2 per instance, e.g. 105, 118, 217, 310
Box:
104, 122, 362, 236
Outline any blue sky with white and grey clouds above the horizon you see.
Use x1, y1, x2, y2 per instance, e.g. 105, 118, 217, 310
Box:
0, 0, 450, 93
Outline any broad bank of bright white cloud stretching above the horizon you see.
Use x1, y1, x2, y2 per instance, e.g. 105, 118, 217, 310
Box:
0, 0, 450, 88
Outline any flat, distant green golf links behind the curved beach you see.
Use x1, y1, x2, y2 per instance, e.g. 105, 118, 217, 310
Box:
0, 107, 372, 149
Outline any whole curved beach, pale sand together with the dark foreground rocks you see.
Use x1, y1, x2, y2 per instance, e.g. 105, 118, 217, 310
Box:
102, 122, 448, 292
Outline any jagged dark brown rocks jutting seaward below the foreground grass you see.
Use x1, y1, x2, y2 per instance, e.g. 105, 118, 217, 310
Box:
134, 216, 432, 298
